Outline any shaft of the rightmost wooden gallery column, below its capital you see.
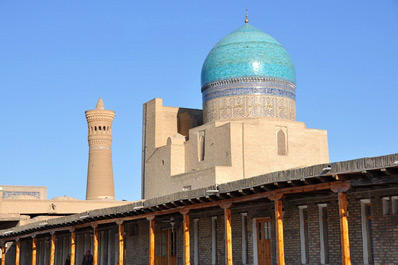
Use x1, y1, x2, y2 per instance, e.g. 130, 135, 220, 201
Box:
338, 192, 351, 265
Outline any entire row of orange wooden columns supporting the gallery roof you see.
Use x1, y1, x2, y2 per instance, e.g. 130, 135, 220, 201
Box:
1, 184, 351, 265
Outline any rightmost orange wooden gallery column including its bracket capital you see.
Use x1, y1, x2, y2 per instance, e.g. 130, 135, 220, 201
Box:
331, 182, 351, 265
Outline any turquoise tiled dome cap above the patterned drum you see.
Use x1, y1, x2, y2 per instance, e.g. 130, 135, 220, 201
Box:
202, 24, 296, 90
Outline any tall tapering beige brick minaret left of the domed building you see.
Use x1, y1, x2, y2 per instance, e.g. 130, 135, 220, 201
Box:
86, 98, 115, 200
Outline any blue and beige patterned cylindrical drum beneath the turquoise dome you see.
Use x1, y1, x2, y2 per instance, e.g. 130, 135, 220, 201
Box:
202, 77, 296, 123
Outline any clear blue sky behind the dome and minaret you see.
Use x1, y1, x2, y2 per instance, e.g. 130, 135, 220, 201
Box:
0, 0, 398, 200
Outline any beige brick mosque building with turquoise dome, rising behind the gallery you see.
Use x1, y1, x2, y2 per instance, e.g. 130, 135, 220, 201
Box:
142, 23, 329, 199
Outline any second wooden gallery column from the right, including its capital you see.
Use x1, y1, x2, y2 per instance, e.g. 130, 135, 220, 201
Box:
269, 193, 285, 265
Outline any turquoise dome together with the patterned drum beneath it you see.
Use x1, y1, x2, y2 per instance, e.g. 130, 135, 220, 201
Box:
202, 24, 296, 122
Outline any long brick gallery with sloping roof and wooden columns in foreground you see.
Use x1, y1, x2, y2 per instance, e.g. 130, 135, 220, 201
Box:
0, 154, 398, 265
